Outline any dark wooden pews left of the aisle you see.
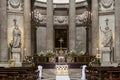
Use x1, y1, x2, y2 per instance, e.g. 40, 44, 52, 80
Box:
0, 67, 35, 80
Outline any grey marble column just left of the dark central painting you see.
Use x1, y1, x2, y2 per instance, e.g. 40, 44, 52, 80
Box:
46, 0, 54, 50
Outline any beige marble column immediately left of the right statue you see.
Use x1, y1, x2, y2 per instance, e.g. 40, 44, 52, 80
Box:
91, 0, 99, 55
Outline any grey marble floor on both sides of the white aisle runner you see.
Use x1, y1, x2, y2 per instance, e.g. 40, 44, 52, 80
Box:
42, 69, 82, 80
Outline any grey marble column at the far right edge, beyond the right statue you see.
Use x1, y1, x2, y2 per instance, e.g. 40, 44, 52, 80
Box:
114, 0, 120, 62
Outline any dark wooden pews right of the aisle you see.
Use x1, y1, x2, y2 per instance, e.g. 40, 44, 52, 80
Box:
86, 67, 120, 80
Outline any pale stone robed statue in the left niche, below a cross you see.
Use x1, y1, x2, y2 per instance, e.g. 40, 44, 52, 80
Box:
12, 19, 21, 48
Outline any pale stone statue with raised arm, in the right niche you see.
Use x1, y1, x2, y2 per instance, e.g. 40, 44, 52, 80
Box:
100, 19, 112, 47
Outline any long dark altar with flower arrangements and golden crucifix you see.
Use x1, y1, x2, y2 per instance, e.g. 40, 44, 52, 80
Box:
33, 38, 91, 68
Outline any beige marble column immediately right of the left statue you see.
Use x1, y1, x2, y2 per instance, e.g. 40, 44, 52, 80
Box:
24, 0, 31, 56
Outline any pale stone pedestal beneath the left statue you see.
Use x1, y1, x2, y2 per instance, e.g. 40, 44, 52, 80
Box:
11, 48, 22, 67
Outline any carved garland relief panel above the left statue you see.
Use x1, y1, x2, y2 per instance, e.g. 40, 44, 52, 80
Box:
7, 0, 23, 11
